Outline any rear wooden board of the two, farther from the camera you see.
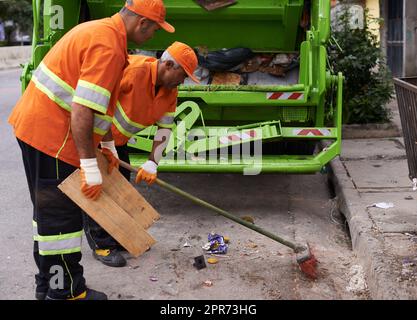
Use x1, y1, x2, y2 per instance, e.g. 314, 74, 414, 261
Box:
97, 152, 160, 229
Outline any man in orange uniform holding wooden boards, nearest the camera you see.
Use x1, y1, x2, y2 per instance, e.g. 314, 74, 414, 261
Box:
9, 0, 175, 300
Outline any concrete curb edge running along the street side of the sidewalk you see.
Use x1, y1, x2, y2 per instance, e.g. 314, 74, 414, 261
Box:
329, 158, 413, 300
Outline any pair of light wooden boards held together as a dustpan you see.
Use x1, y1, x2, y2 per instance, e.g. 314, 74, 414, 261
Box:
58, 151, 160, 257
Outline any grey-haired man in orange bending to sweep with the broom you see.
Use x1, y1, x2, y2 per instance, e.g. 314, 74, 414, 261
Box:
84, 42, 198, 267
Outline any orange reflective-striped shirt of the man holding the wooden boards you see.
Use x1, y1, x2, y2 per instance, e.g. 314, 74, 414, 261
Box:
9, 14, 128, 166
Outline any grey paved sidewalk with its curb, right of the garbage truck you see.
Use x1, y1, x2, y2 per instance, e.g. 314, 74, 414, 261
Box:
330, 103, 417, 299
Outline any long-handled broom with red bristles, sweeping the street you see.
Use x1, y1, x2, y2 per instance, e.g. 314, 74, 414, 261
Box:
120, 160, 317, 279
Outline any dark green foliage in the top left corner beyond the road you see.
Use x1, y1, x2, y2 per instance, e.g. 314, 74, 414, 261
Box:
0, 0, 33, 45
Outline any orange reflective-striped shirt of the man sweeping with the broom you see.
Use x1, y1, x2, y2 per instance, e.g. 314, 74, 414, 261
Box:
112, 55, 178, 146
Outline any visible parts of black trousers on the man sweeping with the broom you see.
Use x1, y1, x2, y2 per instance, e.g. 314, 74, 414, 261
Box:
84, 144, 130, 250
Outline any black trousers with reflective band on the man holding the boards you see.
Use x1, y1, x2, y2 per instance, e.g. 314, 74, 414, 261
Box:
17, 139, 86, 299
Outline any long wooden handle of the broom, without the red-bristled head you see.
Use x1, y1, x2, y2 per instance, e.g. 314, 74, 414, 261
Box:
119, 160, 299, 251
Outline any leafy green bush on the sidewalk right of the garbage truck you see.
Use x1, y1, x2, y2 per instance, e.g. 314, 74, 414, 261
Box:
328, 8, 394, 123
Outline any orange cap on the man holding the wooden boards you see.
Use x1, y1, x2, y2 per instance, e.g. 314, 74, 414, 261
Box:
125, 0, 175, 33
